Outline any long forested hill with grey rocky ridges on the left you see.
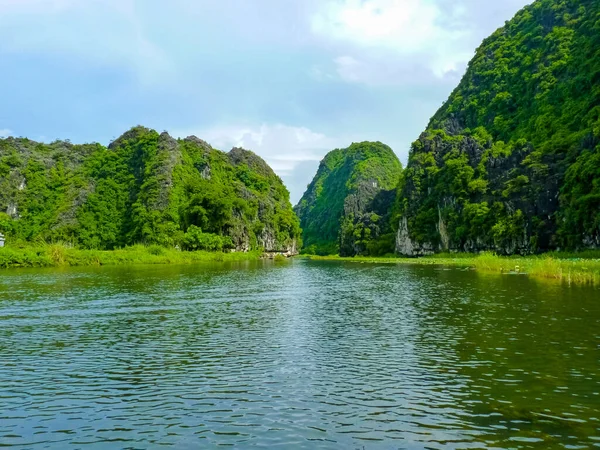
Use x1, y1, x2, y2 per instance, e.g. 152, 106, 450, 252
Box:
0, 127, 300, 252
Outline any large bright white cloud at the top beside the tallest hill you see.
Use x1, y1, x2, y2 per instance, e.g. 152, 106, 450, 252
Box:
311, 0, 531, 86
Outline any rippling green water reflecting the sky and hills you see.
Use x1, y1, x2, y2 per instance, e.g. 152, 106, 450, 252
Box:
0, 260, 600, 450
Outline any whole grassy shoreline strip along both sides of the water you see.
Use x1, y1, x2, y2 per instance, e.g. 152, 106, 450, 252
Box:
0, 244, 600, 286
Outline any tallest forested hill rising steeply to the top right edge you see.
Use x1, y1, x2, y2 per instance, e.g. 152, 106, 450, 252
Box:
397, 0, 600, 255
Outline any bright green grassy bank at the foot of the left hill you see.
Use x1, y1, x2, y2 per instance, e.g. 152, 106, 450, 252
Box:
0, 244, 261, 268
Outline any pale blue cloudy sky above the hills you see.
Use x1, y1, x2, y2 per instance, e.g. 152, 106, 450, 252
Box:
0, 0, 531, 203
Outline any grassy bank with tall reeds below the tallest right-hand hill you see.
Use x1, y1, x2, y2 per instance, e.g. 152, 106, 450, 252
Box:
304, 252, 600, 286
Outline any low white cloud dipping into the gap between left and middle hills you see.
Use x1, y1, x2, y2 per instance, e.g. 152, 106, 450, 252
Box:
173, 124, 351, 203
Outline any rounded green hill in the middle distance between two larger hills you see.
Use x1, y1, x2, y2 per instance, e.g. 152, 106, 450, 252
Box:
295, 142, 402, 256
